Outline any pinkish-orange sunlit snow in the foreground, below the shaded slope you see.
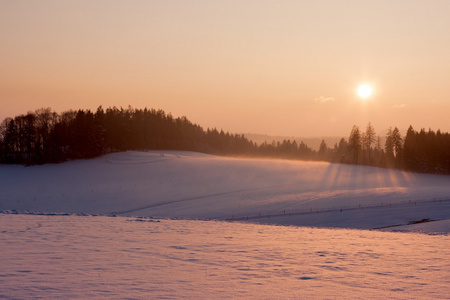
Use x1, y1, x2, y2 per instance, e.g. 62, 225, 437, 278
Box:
0, 214, 450, 299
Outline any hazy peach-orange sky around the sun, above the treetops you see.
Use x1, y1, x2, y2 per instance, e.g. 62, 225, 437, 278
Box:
0, 0, 450, 137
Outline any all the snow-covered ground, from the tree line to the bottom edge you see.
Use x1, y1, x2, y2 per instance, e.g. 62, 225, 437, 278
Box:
0, 151, 450, 299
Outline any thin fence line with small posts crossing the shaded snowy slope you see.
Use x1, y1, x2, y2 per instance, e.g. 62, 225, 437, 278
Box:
223, 198, 450, 221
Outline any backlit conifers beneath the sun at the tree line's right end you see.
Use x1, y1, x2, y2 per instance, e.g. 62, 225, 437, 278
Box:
318, 122, 450, 174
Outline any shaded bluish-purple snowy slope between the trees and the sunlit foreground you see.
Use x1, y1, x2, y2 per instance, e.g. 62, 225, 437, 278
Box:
0, 151, 450, 229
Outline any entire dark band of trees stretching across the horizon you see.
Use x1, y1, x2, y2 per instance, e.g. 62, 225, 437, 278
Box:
0, 106, 450, 174
